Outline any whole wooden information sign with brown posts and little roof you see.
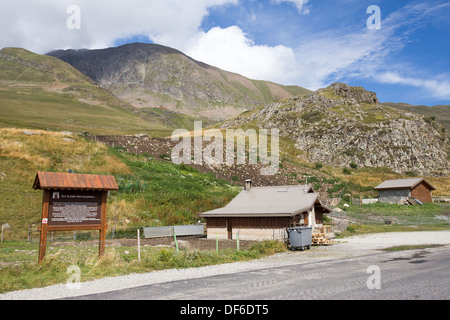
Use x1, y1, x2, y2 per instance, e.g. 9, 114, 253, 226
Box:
33, 172, 118, 263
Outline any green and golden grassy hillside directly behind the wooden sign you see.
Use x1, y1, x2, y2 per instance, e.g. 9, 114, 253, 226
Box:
0, 129, 239, 239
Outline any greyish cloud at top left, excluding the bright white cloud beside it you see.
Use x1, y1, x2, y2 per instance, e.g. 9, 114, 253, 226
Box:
0, 0, 238, 53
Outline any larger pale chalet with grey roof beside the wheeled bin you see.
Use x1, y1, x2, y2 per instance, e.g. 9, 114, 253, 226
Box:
200, 183, 330, 240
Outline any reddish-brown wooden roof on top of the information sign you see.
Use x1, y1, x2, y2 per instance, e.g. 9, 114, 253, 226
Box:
33, 171, 119, 191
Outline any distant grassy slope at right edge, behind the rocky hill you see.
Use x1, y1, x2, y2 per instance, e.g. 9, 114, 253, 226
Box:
383, 102, 450, 130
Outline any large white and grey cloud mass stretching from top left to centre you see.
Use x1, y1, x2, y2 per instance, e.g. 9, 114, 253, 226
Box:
0, 0, 295, 82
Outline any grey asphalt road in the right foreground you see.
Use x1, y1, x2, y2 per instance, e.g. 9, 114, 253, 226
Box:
68, 246, 450, 301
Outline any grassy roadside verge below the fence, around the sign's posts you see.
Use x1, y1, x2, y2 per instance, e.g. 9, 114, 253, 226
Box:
0, 241, 286, 293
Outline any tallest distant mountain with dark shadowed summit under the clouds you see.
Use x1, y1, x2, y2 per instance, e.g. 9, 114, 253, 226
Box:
48, 43, 310, 120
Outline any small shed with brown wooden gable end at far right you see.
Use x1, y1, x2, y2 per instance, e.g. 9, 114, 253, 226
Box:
375, 178, 436, 203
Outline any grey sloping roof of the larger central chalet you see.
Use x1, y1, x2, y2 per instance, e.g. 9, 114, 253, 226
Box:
200, 185, 327, 217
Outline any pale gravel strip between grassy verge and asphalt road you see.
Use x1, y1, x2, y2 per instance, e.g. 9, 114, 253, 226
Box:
0, 231, 450, 300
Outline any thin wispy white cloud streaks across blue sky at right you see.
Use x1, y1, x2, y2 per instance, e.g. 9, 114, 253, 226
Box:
288, 3, 450, 99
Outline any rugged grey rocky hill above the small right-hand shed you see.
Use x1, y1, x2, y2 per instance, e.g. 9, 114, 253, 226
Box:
222, 83, 450, 176
